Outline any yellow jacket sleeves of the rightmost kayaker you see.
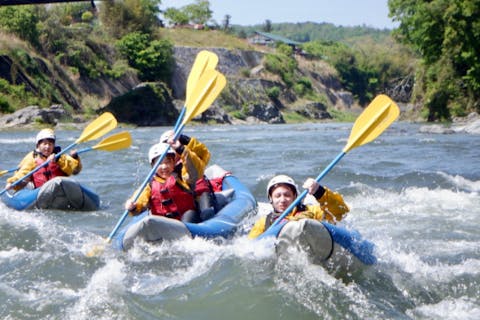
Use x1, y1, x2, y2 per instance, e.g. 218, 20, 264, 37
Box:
248, 187, 350, 239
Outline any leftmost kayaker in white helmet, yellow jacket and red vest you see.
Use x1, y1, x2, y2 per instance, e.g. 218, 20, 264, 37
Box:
5, 129, 82, 190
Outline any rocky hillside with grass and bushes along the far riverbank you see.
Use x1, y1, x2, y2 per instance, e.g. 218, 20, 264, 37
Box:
0, 8, 412, 125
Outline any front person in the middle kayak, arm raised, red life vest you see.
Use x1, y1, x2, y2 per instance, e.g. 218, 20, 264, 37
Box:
125, 132, 210, 222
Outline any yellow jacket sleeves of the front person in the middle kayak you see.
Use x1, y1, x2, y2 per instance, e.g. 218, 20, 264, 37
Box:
129, 137, 210, 214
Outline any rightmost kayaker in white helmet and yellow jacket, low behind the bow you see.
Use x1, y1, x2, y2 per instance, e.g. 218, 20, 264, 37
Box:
248, 175, 350, 239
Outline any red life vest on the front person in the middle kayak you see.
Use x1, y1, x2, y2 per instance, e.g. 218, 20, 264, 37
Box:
150, 176, 195, 220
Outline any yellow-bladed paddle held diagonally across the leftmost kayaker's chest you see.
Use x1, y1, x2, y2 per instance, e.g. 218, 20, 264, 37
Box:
0, 112, 117, 196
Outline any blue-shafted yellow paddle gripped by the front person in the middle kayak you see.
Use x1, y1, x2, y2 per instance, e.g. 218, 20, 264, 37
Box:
86, 69, 227, 257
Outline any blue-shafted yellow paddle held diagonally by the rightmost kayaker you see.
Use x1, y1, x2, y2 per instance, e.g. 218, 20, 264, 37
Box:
257, 95, 400, 239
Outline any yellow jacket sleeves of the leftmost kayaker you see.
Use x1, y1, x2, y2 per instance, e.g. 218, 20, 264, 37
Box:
7, 151, 82, 190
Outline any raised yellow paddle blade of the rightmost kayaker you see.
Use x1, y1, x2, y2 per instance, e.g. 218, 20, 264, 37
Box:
343, 94, 400, 153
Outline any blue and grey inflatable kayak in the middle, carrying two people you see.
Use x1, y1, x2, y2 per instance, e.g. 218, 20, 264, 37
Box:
113, 165, 257, 250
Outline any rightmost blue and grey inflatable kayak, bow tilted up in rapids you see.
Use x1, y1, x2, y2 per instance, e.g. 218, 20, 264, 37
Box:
262, 219, 377, 270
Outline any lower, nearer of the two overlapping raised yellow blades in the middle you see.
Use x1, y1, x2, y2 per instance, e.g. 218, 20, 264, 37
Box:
182, 69, 227, 124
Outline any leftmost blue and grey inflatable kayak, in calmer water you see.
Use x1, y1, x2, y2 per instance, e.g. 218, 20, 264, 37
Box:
2, 177, 100, 211
